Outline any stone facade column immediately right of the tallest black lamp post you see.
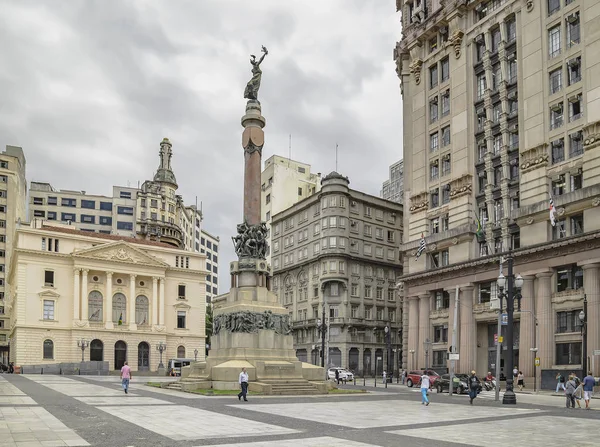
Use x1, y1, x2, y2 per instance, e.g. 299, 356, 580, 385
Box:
519, 276, 537, 377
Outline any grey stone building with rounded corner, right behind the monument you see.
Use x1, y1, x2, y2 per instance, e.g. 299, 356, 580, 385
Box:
271, 172, 403, 374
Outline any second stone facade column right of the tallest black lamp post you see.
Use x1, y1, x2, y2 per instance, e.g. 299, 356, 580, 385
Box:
536, 272, 554, 374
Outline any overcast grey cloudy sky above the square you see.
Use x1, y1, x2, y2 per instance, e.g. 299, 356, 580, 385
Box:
0, 0, 402, 292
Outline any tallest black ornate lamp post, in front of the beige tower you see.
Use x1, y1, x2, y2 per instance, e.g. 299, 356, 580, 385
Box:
497, 253, 523, 405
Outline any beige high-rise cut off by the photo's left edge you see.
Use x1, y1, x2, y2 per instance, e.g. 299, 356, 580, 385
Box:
0, 146, 27, 365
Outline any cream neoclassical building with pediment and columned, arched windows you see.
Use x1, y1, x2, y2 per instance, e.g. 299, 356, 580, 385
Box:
7, 220, 207, 371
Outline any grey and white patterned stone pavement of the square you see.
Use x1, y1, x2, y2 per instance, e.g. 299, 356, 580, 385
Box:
0, 375, 600, 447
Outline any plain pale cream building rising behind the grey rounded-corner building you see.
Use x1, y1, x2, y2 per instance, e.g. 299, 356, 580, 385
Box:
261, 155, 321, 263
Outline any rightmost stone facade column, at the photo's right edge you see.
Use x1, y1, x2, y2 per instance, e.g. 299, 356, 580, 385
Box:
583, 264, 600, 377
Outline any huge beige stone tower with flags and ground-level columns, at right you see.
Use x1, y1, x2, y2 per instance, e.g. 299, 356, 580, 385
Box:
394, 0, 600, 388
